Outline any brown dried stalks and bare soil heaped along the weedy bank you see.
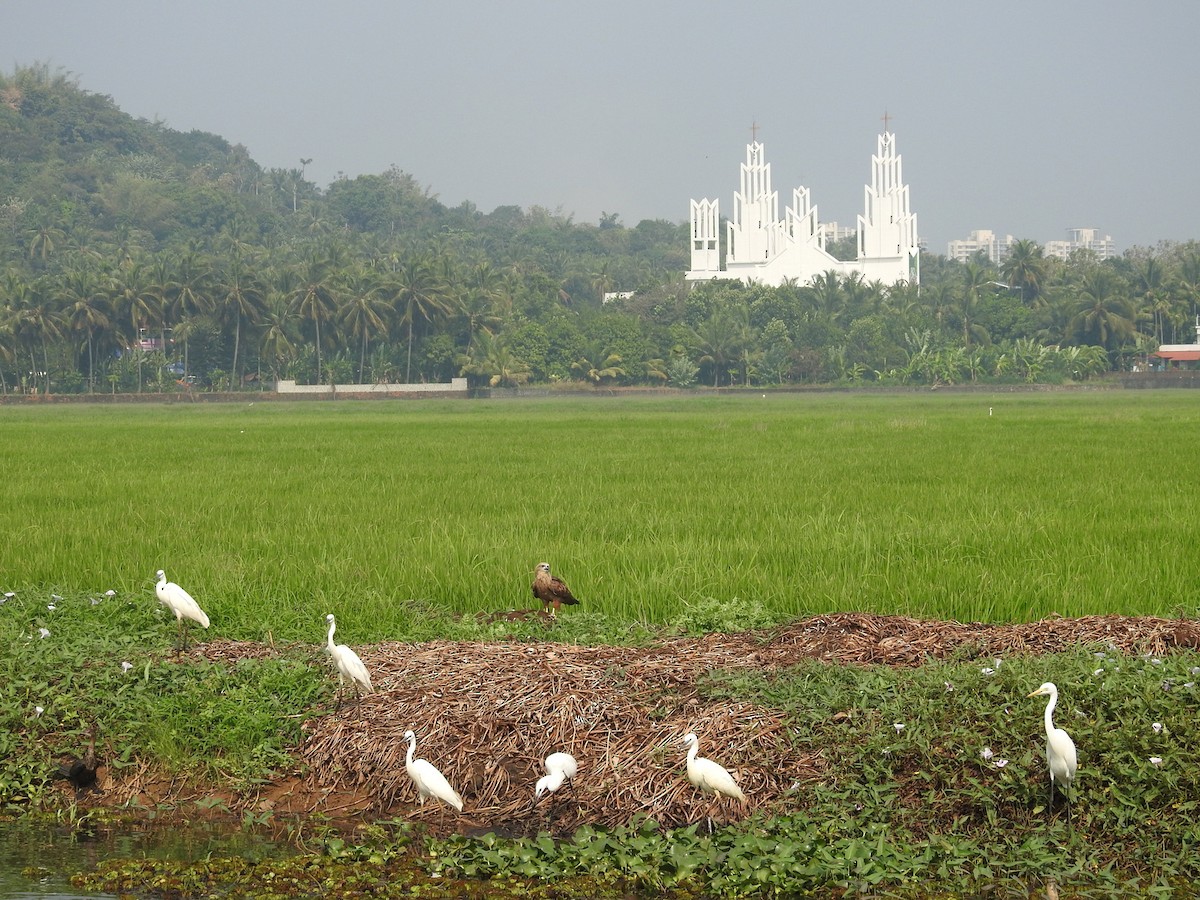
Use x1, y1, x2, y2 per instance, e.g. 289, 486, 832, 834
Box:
65, 613, 1200, 833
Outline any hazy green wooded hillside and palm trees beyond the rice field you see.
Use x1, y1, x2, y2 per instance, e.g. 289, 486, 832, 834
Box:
0, 65, 1200, 394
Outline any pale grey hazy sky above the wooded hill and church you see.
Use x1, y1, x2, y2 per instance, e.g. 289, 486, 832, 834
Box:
0, 0, 1200, 253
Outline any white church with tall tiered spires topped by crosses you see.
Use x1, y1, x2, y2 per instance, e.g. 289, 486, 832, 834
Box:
686, 131, 920, 287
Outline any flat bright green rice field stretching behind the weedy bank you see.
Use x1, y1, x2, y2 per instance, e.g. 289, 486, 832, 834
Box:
0, 390, 1200, 641
